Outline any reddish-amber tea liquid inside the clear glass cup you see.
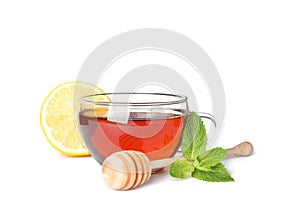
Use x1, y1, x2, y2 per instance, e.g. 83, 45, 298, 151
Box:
79, 110, 186, 163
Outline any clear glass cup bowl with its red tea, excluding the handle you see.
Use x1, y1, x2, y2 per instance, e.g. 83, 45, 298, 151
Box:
79, 93, 188, 164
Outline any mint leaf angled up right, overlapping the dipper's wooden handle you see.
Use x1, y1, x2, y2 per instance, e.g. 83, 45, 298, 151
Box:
195, 147, 227, 167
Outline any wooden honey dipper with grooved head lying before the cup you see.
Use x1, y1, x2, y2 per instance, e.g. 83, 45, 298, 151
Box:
102, 142, 253, 190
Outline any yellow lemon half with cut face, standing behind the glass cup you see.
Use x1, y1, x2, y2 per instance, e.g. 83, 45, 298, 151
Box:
40, 82, 110, 156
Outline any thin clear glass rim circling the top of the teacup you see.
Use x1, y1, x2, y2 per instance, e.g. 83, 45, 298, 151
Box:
80, 92, 187, 106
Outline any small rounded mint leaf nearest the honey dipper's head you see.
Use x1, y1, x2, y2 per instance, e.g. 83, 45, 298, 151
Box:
169, 160, 195, 179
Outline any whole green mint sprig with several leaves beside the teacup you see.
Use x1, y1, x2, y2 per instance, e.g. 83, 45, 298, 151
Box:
169, 112, 234, 182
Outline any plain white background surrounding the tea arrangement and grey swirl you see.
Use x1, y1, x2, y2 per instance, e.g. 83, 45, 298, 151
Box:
0, 0, 300, 199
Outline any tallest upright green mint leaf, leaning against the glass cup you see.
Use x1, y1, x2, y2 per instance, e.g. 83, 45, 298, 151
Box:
181, 112, 207, 160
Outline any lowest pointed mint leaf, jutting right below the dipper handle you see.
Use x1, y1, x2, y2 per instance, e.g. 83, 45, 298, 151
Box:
192, 163, 234, 182
